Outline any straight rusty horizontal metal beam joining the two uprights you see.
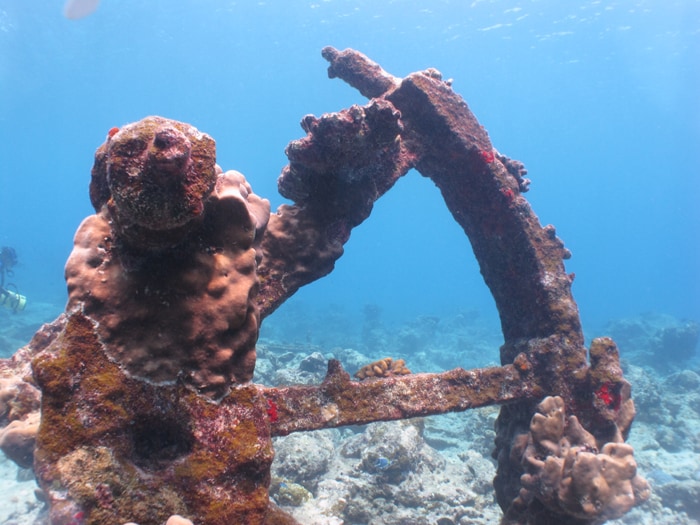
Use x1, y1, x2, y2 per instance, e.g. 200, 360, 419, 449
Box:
263, 356, 542, 436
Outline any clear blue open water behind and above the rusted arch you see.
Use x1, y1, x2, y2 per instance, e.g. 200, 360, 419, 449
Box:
0, 0, 700, 351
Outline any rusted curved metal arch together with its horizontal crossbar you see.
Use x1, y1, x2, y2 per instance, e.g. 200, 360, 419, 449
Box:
258, 47, 633, 523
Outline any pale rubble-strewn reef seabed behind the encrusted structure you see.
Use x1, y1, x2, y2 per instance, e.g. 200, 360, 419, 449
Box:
0, 312, 700, 525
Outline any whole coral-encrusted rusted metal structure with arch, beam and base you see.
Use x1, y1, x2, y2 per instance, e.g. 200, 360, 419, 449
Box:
0, 48, 649, 525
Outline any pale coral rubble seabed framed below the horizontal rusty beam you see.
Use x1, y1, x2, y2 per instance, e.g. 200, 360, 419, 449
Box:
272, 411, 499, 525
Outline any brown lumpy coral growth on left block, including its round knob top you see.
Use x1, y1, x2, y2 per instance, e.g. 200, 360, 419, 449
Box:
66, 117, 270, 397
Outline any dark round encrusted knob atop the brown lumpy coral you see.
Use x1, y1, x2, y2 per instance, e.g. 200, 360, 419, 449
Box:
91, 117, 216, 242
